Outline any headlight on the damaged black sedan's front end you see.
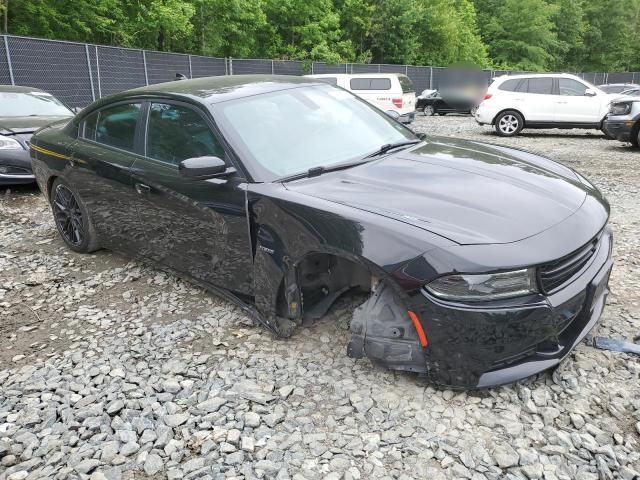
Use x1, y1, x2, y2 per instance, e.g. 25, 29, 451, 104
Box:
425, 268, 538, 302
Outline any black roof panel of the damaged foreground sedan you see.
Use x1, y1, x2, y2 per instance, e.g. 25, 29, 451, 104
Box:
95, 75, 326, 104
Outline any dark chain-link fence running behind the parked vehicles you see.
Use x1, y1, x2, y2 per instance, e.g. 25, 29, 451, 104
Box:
0, 35, 640, 107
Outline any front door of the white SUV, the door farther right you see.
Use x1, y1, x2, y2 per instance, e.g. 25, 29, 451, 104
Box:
555, 78, 605, 124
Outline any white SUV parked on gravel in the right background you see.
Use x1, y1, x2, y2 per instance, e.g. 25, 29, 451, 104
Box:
475, 74, 612, 137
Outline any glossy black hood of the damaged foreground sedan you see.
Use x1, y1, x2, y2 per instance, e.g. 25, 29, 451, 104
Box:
286, 138, 589, 244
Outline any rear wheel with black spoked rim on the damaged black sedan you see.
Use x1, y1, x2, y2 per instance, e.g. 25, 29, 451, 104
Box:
51, 178, 100, 253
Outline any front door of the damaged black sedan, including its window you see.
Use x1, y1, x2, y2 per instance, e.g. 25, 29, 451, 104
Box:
132, 101, 253, 295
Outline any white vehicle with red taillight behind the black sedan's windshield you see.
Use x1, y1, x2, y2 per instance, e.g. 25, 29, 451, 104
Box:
307, 73, 416, 123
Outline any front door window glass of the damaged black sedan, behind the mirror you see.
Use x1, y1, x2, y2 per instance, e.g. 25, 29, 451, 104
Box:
147, 103, 224, 165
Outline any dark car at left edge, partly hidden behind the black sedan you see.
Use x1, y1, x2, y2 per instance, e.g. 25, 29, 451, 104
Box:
0, 85, 73, 185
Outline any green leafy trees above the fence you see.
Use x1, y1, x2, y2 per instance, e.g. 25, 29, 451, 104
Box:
0, 0, 640, 71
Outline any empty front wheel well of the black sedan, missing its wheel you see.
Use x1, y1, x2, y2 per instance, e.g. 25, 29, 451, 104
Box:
276, 253, 375, 324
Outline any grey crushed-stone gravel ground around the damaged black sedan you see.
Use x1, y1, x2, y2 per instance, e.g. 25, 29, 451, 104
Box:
0, 115, 640, 480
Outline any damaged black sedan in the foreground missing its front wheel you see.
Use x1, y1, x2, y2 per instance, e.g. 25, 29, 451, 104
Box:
32, 76, 612, 387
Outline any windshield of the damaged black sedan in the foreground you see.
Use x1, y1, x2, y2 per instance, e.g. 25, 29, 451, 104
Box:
214, 85, 416, 181
